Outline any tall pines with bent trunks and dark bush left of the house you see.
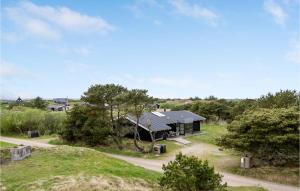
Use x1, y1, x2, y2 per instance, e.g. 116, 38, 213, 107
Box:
61, 84, 154, 152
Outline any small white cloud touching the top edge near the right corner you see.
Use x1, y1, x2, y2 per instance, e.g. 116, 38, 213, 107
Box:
264, 0, 287, 25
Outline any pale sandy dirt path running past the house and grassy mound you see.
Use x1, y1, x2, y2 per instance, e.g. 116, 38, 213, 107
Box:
0, 136, 300, 191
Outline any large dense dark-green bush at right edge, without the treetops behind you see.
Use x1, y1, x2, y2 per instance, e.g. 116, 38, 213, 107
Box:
218, 108, 299, 166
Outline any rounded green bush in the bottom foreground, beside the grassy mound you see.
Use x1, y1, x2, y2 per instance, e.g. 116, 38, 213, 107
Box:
160, 153, 227, 191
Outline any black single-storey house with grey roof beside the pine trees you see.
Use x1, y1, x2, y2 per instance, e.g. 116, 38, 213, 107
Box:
126, 111, 205, 140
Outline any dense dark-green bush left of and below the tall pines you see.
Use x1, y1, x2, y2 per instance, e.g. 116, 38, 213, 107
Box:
60, 106, 111, 146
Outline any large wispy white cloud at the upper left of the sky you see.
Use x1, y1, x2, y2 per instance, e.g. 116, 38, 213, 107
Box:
5, 1, 114, 39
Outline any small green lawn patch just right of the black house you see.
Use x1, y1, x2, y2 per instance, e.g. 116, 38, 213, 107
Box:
186, 124, 227, 145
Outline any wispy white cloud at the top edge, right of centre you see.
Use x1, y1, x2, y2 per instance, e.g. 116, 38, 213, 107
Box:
170, 0, 218, 24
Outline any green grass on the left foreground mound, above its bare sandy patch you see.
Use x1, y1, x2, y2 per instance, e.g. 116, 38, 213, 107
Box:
1, 146, 160, 190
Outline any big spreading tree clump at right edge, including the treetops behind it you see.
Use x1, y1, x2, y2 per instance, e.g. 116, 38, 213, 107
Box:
218, 90, 300, 166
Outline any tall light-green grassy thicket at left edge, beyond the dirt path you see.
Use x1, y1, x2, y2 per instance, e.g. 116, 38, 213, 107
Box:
0, 107, 66, 134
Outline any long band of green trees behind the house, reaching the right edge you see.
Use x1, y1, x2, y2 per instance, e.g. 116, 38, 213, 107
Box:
162, 90, 299, 123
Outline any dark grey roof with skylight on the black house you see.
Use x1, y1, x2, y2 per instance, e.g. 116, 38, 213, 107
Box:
127, 111, 205, 131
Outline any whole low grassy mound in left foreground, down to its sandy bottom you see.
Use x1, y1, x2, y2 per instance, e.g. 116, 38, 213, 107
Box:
1, 146, 160, 190
